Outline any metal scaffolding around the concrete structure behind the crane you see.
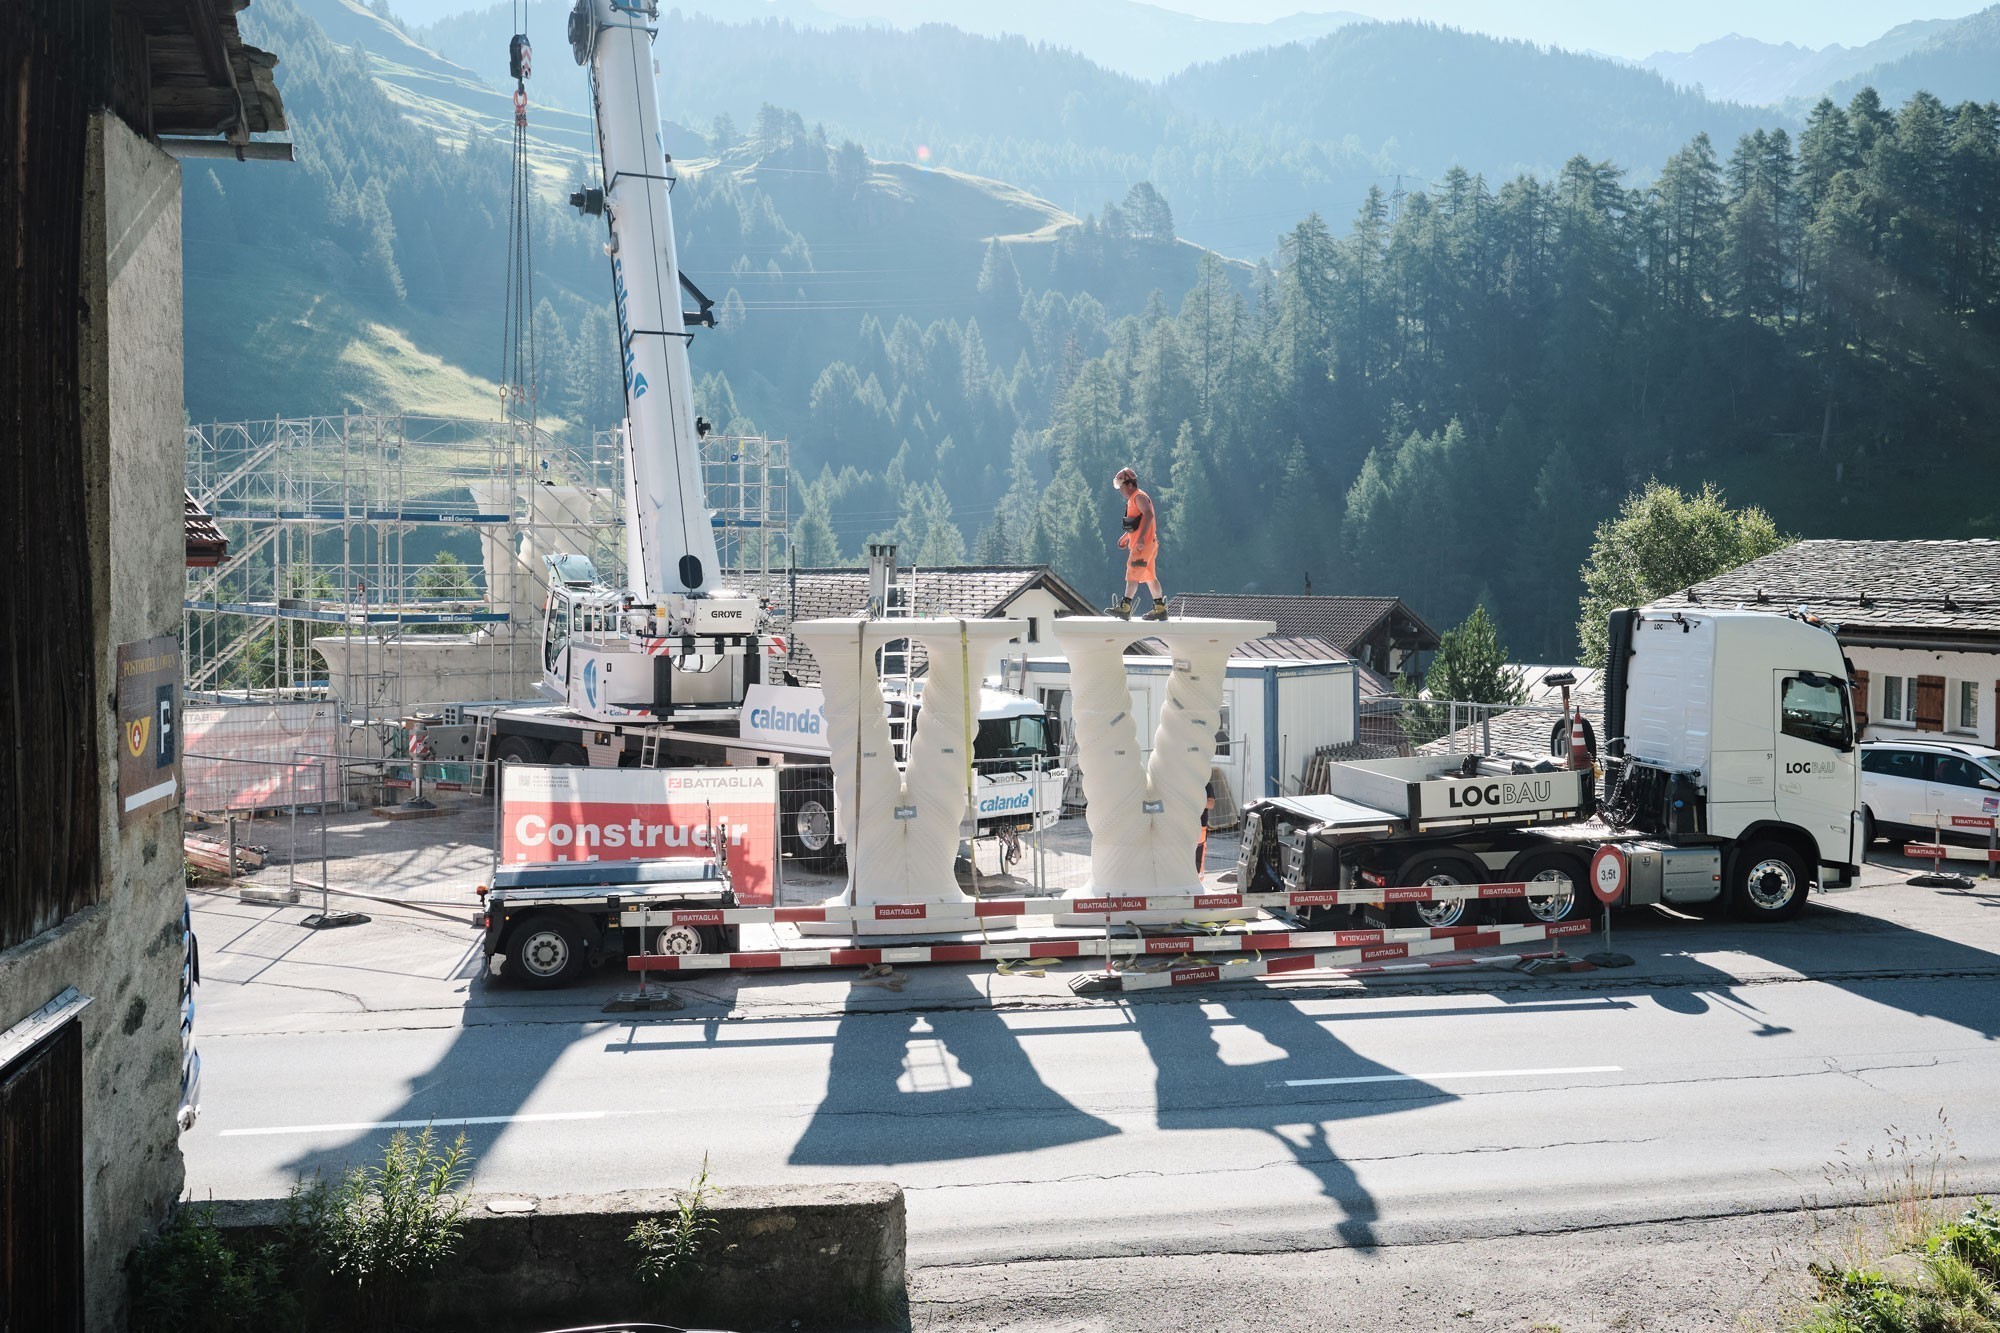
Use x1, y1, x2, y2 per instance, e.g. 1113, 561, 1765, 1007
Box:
182, 412, 790, 703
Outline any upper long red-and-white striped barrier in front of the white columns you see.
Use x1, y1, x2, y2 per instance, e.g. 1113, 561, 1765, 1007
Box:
618, 879, 1568, 927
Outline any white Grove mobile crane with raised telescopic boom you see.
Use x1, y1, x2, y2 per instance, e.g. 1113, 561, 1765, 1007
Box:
460, 0, 1064, 869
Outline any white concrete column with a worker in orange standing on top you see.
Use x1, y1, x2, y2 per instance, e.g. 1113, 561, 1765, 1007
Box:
1054, 616, 1272, 908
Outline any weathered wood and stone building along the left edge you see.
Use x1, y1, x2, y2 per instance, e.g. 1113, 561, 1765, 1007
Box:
0, 0, 288, 1333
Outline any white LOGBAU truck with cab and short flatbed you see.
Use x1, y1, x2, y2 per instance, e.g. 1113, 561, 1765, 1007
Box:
1236, 606, 1864, 927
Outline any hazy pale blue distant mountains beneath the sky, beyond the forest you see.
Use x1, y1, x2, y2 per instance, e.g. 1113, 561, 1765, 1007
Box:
406, 0, 1758, 258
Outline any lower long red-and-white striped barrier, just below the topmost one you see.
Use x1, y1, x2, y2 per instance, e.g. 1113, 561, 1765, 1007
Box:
626, 923, 1560, 977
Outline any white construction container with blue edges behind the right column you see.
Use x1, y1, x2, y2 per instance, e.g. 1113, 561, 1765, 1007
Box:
1008, 656, 1360, 805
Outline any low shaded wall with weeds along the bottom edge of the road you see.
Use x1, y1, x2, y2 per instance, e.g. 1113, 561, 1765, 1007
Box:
214, 1176, 906, 1333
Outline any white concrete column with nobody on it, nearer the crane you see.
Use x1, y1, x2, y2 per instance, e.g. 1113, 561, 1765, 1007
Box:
792, 618, 1028, 935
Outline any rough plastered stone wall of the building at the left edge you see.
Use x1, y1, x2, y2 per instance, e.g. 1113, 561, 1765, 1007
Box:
0, 114, 184, 1329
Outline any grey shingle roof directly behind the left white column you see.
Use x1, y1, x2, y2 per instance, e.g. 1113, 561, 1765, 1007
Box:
730, 564, 1096, 685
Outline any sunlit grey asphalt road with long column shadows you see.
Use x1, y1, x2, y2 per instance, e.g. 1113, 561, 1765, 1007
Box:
184, 856, 2000, 1265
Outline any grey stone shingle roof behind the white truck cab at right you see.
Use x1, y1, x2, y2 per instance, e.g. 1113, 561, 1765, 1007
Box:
1658, 538, 2000, 642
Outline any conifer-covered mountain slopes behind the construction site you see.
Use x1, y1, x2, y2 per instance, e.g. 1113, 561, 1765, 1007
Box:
186, 0, 2000, 660
